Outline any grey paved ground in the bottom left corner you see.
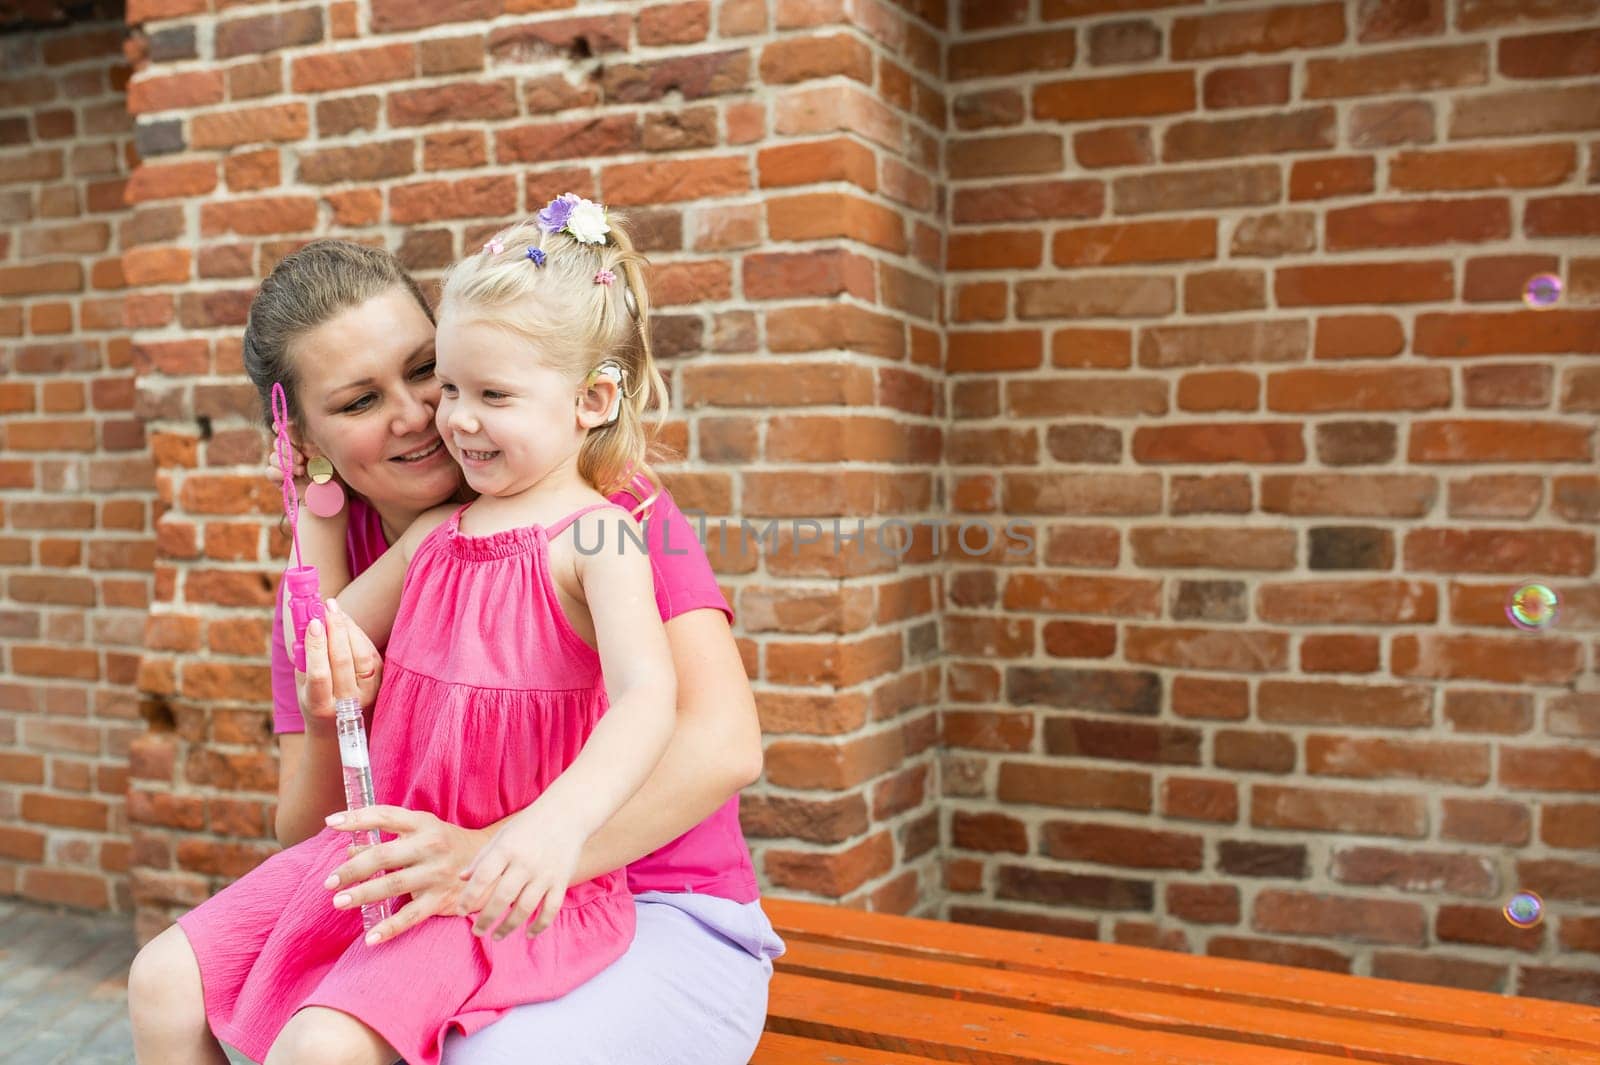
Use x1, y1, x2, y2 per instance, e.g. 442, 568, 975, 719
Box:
0, 899, 245, 1065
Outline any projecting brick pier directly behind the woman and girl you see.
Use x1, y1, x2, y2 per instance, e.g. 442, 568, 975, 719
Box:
118, 0, 944, 932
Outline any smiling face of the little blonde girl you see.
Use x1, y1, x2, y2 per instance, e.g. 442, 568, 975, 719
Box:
437, 312, 610, 499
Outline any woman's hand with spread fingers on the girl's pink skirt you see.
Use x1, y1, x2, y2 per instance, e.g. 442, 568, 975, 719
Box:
323, 806, 488, 943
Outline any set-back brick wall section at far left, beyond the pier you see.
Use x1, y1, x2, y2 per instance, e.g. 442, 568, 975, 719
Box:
0, 16, 154, 908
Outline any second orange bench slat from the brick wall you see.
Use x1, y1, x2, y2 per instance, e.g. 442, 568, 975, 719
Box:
778, 940, 1600, 1065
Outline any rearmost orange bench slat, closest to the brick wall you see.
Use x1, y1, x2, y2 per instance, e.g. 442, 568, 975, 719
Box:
762, 899, 1600, 1051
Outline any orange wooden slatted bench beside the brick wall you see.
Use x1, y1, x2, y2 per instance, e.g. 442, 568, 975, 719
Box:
750, 900, 1600, 1065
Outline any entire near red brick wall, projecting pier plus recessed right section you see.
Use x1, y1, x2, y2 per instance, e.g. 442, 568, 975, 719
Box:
0, 0, 1600, 999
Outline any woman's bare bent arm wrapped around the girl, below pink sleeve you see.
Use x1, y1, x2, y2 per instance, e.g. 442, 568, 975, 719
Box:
573, 609, 762, 883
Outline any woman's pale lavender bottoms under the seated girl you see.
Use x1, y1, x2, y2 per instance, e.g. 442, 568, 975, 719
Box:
443, 891, 784, 1065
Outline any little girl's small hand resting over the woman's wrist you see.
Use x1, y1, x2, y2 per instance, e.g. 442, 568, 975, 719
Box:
461, 801, 587, 940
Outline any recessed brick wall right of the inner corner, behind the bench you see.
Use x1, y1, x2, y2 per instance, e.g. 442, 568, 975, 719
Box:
942, 0, 1600, 1001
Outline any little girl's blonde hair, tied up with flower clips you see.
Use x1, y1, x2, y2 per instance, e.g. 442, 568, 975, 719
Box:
438, 211, 670, 515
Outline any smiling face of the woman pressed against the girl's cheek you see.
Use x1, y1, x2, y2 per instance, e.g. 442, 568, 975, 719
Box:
290, 288, 461, 513
